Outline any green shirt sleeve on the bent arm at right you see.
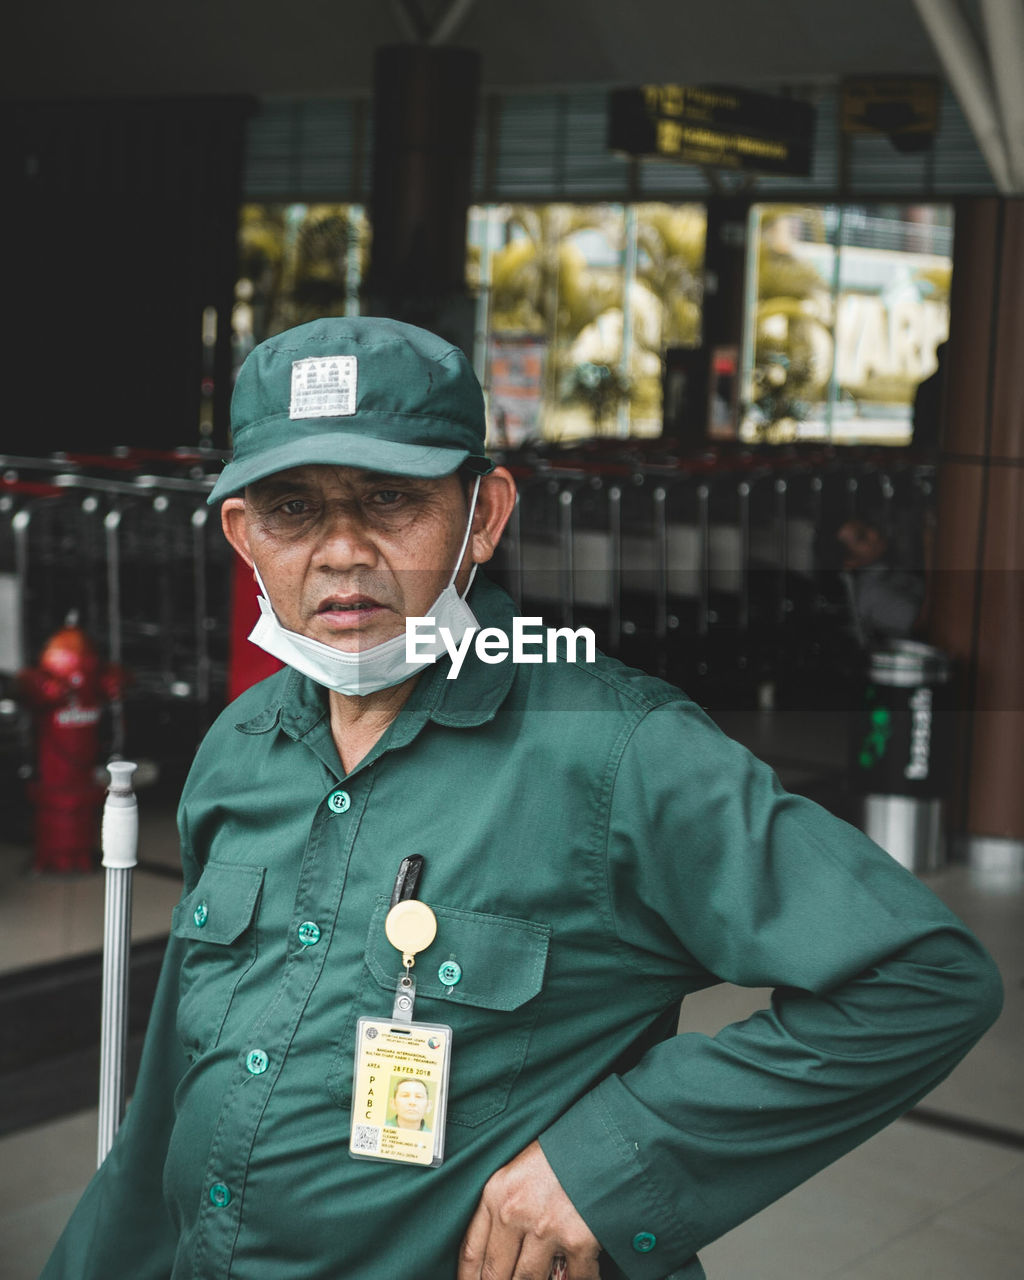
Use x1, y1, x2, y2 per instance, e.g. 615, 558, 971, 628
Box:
540, 703, 1001, 1280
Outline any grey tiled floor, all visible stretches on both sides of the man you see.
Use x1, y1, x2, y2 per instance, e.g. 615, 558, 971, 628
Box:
0, 713, 1024, 1280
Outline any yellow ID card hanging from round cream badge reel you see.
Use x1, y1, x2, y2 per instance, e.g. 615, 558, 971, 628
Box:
348, 899, 452, 1166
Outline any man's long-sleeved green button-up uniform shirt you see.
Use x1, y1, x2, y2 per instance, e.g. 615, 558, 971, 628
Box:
45, 582, 1000, 1280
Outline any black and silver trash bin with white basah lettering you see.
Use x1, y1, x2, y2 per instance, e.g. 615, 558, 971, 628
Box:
854, 640, 952, 872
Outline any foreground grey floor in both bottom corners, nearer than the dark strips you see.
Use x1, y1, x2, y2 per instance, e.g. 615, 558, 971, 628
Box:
10, 1090, 1024, 1280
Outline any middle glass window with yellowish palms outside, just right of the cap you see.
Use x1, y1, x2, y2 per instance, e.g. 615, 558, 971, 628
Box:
467, 204, 707, 445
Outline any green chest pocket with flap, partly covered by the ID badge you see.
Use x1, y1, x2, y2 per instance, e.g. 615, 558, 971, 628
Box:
328, 897, 552, 1126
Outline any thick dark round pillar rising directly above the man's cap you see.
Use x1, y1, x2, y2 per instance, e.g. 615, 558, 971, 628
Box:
364, 45, 479, 356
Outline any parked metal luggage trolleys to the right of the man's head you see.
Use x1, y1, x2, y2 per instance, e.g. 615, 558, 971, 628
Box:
495, 443, 934, 701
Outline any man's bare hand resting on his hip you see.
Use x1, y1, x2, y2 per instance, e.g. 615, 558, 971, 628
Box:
458, 1142, 600, 1280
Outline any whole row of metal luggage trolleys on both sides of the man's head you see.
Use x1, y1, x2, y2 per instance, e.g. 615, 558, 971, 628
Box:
0, 442, 934, 759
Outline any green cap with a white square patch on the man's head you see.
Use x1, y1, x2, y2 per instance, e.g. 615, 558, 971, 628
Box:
209, 316, 493, 503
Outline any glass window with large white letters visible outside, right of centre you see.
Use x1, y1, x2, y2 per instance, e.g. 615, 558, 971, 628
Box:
741, 205, 952, 444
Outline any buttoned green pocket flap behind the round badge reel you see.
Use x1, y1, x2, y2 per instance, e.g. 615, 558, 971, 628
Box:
366, 897, 552, 1016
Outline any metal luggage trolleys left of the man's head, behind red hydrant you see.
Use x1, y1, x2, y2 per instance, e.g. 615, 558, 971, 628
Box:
0, 454, 233, 778
